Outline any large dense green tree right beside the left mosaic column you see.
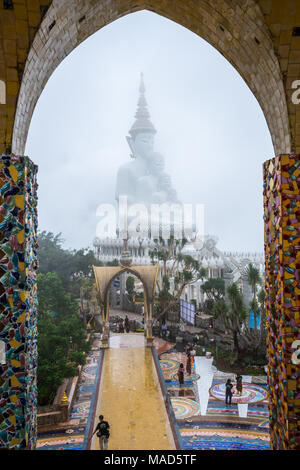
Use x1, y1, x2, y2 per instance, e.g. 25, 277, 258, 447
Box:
38, 273, 91, 405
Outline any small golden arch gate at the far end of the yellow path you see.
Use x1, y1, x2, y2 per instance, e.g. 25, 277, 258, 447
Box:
93, 265, 159, 347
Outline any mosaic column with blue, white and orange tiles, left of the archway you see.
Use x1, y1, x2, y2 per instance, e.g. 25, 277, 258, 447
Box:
0, 155, 37, 449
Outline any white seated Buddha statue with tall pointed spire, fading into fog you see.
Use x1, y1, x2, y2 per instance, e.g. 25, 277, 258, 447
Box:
94, 74, 182, 265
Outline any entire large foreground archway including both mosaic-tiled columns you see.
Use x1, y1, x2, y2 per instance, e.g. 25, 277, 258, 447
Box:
0, 0, 300, 449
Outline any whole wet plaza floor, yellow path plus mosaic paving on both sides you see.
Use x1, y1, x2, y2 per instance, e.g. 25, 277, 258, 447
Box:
37, 333, 270, 450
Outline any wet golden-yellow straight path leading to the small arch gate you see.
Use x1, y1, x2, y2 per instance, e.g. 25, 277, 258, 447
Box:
91, 334, 175, 450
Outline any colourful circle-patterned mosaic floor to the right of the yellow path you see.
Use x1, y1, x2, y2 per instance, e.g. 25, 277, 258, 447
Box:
160, 353, 270, 450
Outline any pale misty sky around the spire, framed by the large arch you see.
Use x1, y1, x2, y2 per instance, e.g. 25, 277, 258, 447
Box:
25, 11, 274, 252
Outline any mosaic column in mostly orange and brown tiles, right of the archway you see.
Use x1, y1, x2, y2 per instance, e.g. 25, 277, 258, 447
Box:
264, 154, 300, 450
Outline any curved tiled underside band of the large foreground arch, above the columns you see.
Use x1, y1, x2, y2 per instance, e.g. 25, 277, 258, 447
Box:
12, 0, 291, 155
